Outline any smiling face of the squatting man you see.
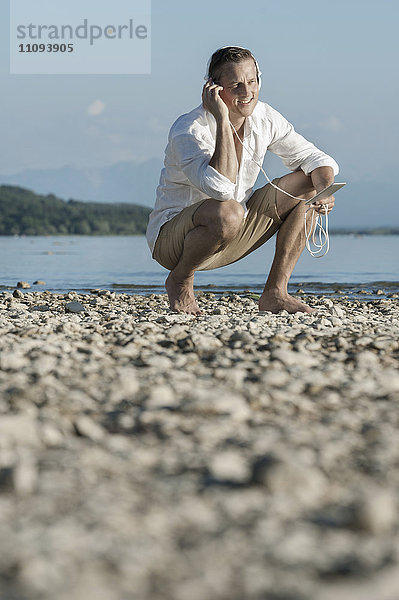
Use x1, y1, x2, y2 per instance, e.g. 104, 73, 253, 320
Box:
217, 58, 259, 119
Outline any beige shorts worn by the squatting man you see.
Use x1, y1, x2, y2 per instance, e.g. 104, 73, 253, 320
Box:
152, 178, 282, 271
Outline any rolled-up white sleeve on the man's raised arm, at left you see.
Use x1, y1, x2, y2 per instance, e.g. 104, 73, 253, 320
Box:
169, 134, 236, 201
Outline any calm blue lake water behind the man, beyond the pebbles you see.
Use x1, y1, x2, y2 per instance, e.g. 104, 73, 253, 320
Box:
0, 236, 399, 297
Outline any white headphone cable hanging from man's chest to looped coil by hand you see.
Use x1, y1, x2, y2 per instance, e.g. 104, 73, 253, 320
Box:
230, 121, 330, 258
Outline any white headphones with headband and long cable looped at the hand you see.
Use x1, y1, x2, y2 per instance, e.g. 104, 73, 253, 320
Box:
204, 46, 330, 258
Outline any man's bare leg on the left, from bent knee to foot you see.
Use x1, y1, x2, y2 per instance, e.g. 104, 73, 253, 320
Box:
165, 198, 244, 314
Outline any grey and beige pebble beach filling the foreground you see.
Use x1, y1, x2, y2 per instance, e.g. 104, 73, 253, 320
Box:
0, 289, 399, 600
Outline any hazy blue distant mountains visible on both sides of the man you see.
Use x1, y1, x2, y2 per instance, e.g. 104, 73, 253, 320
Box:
0, 158, 399, 229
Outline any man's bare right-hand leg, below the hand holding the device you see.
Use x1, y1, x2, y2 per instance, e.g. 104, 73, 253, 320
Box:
259, 171, 316, 313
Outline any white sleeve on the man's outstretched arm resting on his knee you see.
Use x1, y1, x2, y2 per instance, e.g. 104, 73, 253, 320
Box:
268, 107, 339, 175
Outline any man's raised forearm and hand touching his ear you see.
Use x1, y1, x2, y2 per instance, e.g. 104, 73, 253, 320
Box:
202, 80, 237, 183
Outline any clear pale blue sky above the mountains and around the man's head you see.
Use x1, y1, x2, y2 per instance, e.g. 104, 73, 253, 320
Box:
0, 0, 399, 182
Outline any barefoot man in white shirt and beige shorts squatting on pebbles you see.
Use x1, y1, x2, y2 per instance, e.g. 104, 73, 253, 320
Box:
147, 46, 338, 314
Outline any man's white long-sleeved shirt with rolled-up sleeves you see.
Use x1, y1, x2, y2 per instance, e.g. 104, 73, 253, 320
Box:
147, 101, 338, 252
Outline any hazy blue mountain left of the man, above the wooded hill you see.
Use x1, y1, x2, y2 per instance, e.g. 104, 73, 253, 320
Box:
0, 158, 162, 207
